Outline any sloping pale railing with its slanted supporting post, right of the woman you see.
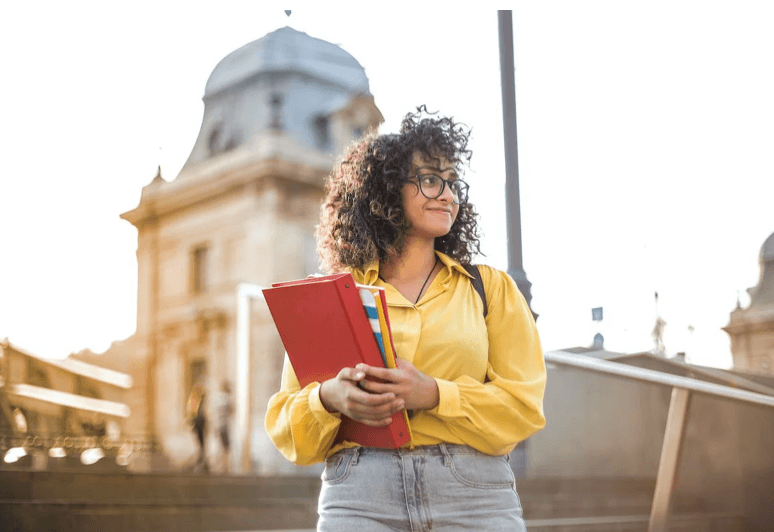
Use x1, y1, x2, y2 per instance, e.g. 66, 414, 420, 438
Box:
545, 351, 774, 532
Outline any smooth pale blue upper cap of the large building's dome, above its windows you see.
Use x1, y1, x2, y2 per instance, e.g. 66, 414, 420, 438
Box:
204, 26, 369, 98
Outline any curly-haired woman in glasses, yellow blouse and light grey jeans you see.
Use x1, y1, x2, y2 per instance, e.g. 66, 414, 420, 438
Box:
266, 107, 546, 532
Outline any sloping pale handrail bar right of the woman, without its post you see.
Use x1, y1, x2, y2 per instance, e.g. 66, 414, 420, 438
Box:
544, 351, 774, 407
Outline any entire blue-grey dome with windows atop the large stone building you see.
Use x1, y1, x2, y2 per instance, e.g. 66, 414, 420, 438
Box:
180, 27, 382, 176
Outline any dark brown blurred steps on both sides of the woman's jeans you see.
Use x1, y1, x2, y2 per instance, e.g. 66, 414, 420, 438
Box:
0, 470, 746, 532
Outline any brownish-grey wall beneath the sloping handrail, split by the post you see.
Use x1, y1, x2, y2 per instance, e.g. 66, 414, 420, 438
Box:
527, 367, 774, 530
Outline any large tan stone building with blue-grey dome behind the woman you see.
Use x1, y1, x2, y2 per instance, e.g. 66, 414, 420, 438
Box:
110, 27, 383, 473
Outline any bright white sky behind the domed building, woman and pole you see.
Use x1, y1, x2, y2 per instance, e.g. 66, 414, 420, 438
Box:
0, 0, 774, 367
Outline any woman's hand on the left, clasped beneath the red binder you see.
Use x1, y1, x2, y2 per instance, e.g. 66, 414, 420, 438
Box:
320, 368, 405, 427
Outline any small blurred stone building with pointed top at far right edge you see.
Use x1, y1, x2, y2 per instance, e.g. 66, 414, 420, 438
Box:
723, 233, 774, 373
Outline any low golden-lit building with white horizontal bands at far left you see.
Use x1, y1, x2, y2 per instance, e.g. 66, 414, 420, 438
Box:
0, 339, 135, 470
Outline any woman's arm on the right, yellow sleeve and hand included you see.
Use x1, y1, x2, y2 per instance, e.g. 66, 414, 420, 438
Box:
358, 267, 546, 455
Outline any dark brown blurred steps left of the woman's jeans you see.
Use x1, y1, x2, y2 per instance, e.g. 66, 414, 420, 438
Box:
0, 471, 320, 532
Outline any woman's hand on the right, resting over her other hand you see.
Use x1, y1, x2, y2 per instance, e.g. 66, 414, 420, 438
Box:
356, 358, 439, 410
